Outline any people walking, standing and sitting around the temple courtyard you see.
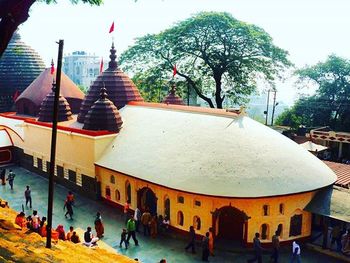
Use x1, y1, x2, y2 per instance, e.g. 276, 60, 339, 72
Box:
0, 169, 350, 263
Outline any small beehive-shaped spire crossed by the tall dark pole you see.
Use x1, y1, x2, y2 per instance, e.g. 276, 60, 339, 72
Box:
38, 83, 72, 122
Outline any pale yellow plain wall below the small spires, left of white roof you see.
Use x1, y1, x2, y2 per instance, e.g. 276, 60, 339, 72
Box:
21, 123, 116, 177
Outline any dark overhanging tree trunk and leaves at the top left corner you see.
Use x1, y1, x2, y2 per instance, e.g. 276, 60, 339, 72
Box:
0, 0, 102, 58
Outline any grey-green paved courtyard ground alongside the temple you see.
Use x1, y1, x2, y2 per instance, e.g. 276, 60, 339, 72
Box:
0, 167, 339, 263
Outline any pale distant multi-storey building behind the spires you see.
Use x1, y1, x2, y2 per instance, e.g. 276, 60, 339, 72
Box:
63, 51, 101, 88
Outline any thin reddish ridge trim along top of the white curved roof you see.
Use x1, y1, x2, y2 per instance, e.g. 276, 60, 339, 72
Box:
127, 101, 238, 117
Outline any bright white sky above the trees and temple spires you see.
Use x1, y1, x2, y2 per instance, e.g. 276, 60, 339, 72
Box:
20, 0, 350, 104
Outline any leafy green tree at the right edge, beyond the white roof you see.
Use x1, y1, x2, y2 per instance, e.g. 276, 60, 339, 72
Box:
277, 55, 350, 131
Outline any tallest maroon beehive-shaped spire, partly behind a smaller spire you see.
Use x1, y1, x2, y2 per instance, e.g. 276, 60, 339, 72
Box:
78, 43, 143, 123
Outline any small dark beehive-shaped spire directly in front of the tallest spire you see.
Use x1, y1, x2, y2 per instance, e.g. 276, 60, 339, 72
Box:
83, 87, 123, 132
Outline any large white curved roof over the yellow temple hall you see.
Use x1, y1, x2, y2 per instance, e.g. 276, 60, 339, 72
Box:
96, 103, 336, 197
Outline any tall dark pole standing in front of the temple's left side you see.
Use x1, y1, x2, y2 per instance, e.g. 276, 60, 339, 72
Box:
46, 40, 63, 248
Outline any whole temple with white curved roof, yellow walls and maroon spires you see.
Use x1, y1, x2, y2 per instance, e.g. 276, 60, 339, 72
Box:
0, 42, 336, 244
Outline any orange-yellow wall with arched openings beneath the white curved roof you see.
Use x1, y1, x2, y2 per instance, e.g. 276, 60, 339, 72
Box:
96, 166, 315, 243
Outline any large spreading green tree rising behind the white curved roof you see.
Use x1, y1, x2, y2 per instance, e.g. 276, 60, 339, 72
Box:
120, 12, 291, 108
